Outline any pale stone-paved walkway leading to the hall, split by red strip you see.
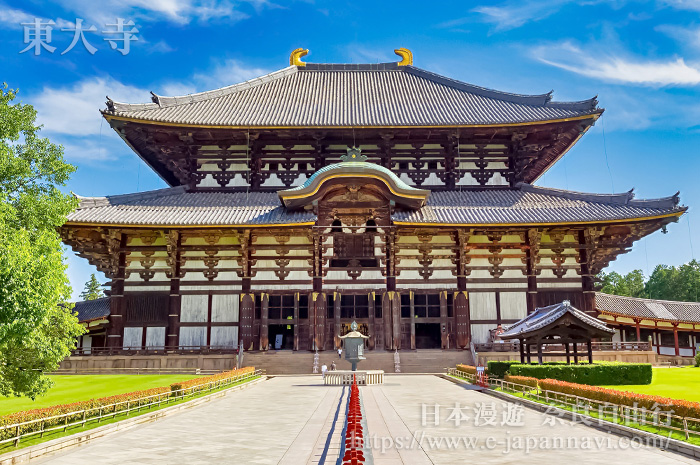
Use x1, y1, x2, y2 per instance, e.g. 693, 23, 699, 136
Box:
36, 376, 695, 465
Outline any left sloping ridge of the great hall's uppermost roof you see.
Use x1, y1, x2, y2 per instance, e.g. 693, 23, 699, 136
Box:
107, 66, 298, 112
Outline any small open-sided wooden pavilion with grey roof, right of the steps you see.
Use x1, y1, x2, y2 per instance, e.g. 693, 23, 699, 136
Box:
499, 300, 615, 364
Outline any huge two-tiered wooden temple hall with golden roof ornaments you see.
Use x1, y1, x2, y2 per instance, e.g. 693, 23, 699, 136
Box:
61, 49, 686, 351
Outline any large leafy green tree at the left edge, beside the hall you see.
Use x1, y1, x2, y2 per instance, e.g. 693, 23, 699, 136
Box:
0, 84, 84, 398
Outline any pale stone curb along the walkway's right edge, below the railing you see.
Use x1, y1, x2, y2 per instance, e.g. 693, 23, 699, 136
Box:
440, 374, 700, 459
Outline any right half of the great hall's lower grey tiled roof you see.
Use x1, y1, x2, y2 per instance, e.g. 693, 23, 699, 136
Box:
393, 183, 685, 224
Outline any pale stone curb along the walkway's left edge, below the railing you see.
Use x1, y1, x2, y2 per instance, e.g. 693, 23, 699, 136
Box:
0, 375, 267, 465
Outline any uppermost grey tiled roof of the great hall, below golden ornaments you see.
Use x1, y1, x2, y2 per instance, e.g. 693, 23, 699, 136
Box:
104, 63, 601, 127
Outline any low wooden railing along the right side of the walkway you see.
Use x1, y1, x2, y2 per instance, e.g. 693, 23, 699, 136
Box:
447, 368, 700, 440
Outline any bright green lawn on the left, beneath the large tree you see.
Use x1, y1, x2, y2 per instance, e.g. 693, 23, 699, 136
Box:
0, 375, 201, 415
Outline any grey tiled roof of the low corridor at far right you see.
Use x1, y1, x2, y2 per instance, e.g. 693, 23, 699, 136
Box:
595, 292, 700, 323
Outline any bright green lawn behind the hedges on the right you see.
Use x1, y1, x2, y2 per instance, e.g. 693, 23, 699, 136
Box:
603, 367, 700, 402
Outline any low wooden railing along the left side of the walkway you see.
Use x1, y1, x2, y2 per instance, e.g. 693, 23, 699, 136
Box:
0, 370, 262, 447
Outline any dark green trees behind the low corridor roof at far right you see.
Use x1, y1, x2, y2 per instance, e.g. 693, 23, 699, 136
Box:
598, 260, 700, 302
